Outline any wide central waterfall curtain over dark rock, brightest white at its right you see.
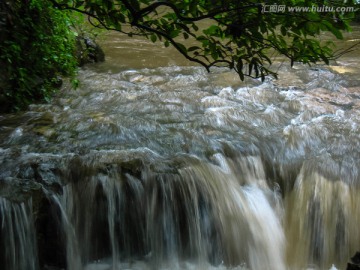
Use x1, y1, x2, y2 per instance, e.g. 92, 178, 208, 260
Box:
27, 154, 286, 270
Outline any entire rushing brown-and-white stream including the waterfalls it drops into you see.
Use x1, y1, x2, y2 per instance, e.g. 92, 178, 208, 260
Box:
0, 25, 360, 270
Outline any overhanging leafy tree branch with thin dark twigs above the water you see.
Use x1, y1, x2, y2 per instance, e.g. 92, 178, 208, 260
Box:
52, 0, 353, 80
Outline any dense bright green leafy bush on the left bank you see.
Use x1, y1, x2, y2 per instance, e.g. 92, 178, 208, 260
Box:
0, 0, 77, 111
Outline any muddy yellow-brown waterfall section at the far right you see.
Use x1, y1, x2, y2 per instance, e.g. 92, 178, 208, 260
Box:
285, 165, 360, 269
